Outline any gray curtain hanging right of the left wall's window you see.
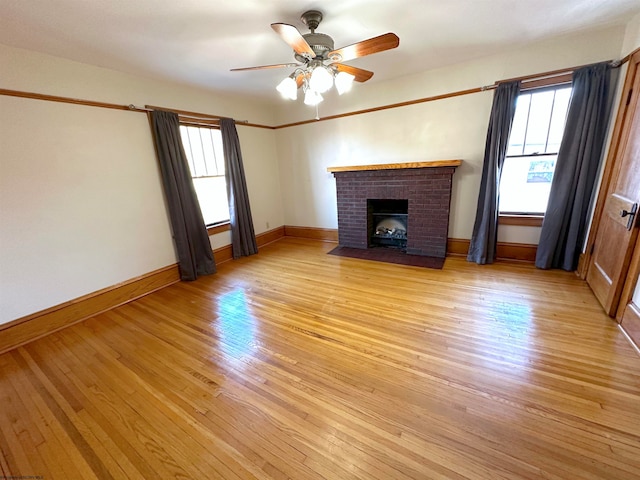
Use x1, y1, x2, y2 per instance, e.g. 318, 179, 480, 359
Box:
220, 118, 258, 258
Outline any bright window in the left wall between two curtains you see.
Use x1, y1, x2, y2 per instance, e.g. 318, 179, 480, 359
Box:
180, 125, 229, 227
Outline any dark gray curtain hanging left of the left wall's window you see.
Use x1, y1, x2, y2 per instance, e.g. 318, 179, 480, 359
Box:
151, 110, 216, 280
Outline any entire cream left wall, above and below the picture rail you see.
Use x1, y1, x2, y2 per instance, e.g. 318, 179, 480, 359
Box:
0, 46, 284, 324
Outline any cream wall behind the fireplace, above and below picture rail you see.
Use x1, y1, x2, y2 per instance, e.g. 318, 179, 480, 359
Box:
276, 27, 625, 243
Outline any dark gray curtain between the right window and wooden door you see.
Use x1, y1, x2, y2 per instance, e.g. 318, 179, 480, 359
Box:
536, 62, 618, 271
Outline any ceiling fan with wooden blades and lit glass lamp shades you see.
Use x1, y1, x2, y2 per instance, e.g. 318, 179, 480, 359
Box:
231, 10, 400, 105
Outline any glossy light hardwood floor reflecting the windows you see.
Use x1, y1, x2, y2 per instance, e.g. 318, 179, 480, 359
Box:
0, 238, 640, 480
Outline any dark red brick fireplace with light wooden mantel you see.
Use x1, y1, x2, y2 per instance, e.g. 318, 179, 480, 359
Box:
328, 160, 462, 258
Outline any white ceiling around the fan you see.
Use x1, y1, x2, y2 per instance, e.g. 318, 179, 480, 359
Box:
0, 0, 640, 98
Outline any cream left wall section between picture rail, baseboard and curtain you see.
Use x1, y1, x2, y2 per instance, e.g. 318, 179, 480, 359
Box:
0, 97, 175, 323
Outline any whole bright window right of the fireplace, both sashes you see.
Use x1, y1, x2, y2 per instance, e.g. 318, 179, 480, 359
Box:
499, 85, 571, 215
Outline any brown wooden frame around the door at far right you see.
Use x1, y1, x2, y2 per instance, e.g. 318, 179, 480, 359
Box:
576, 48, 640, 322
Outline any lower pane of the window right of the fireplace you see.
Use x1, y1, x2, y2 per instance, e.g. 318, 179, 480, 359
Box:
499, 155, 557, 214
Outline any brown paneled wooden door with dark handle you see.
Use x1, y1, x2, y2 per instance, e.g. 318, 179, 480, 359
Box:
587, 55, 640, 316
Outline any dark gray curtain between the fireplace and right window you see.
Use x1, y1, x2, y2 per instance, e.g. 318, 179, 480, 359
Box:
467, 81, 520, 264
